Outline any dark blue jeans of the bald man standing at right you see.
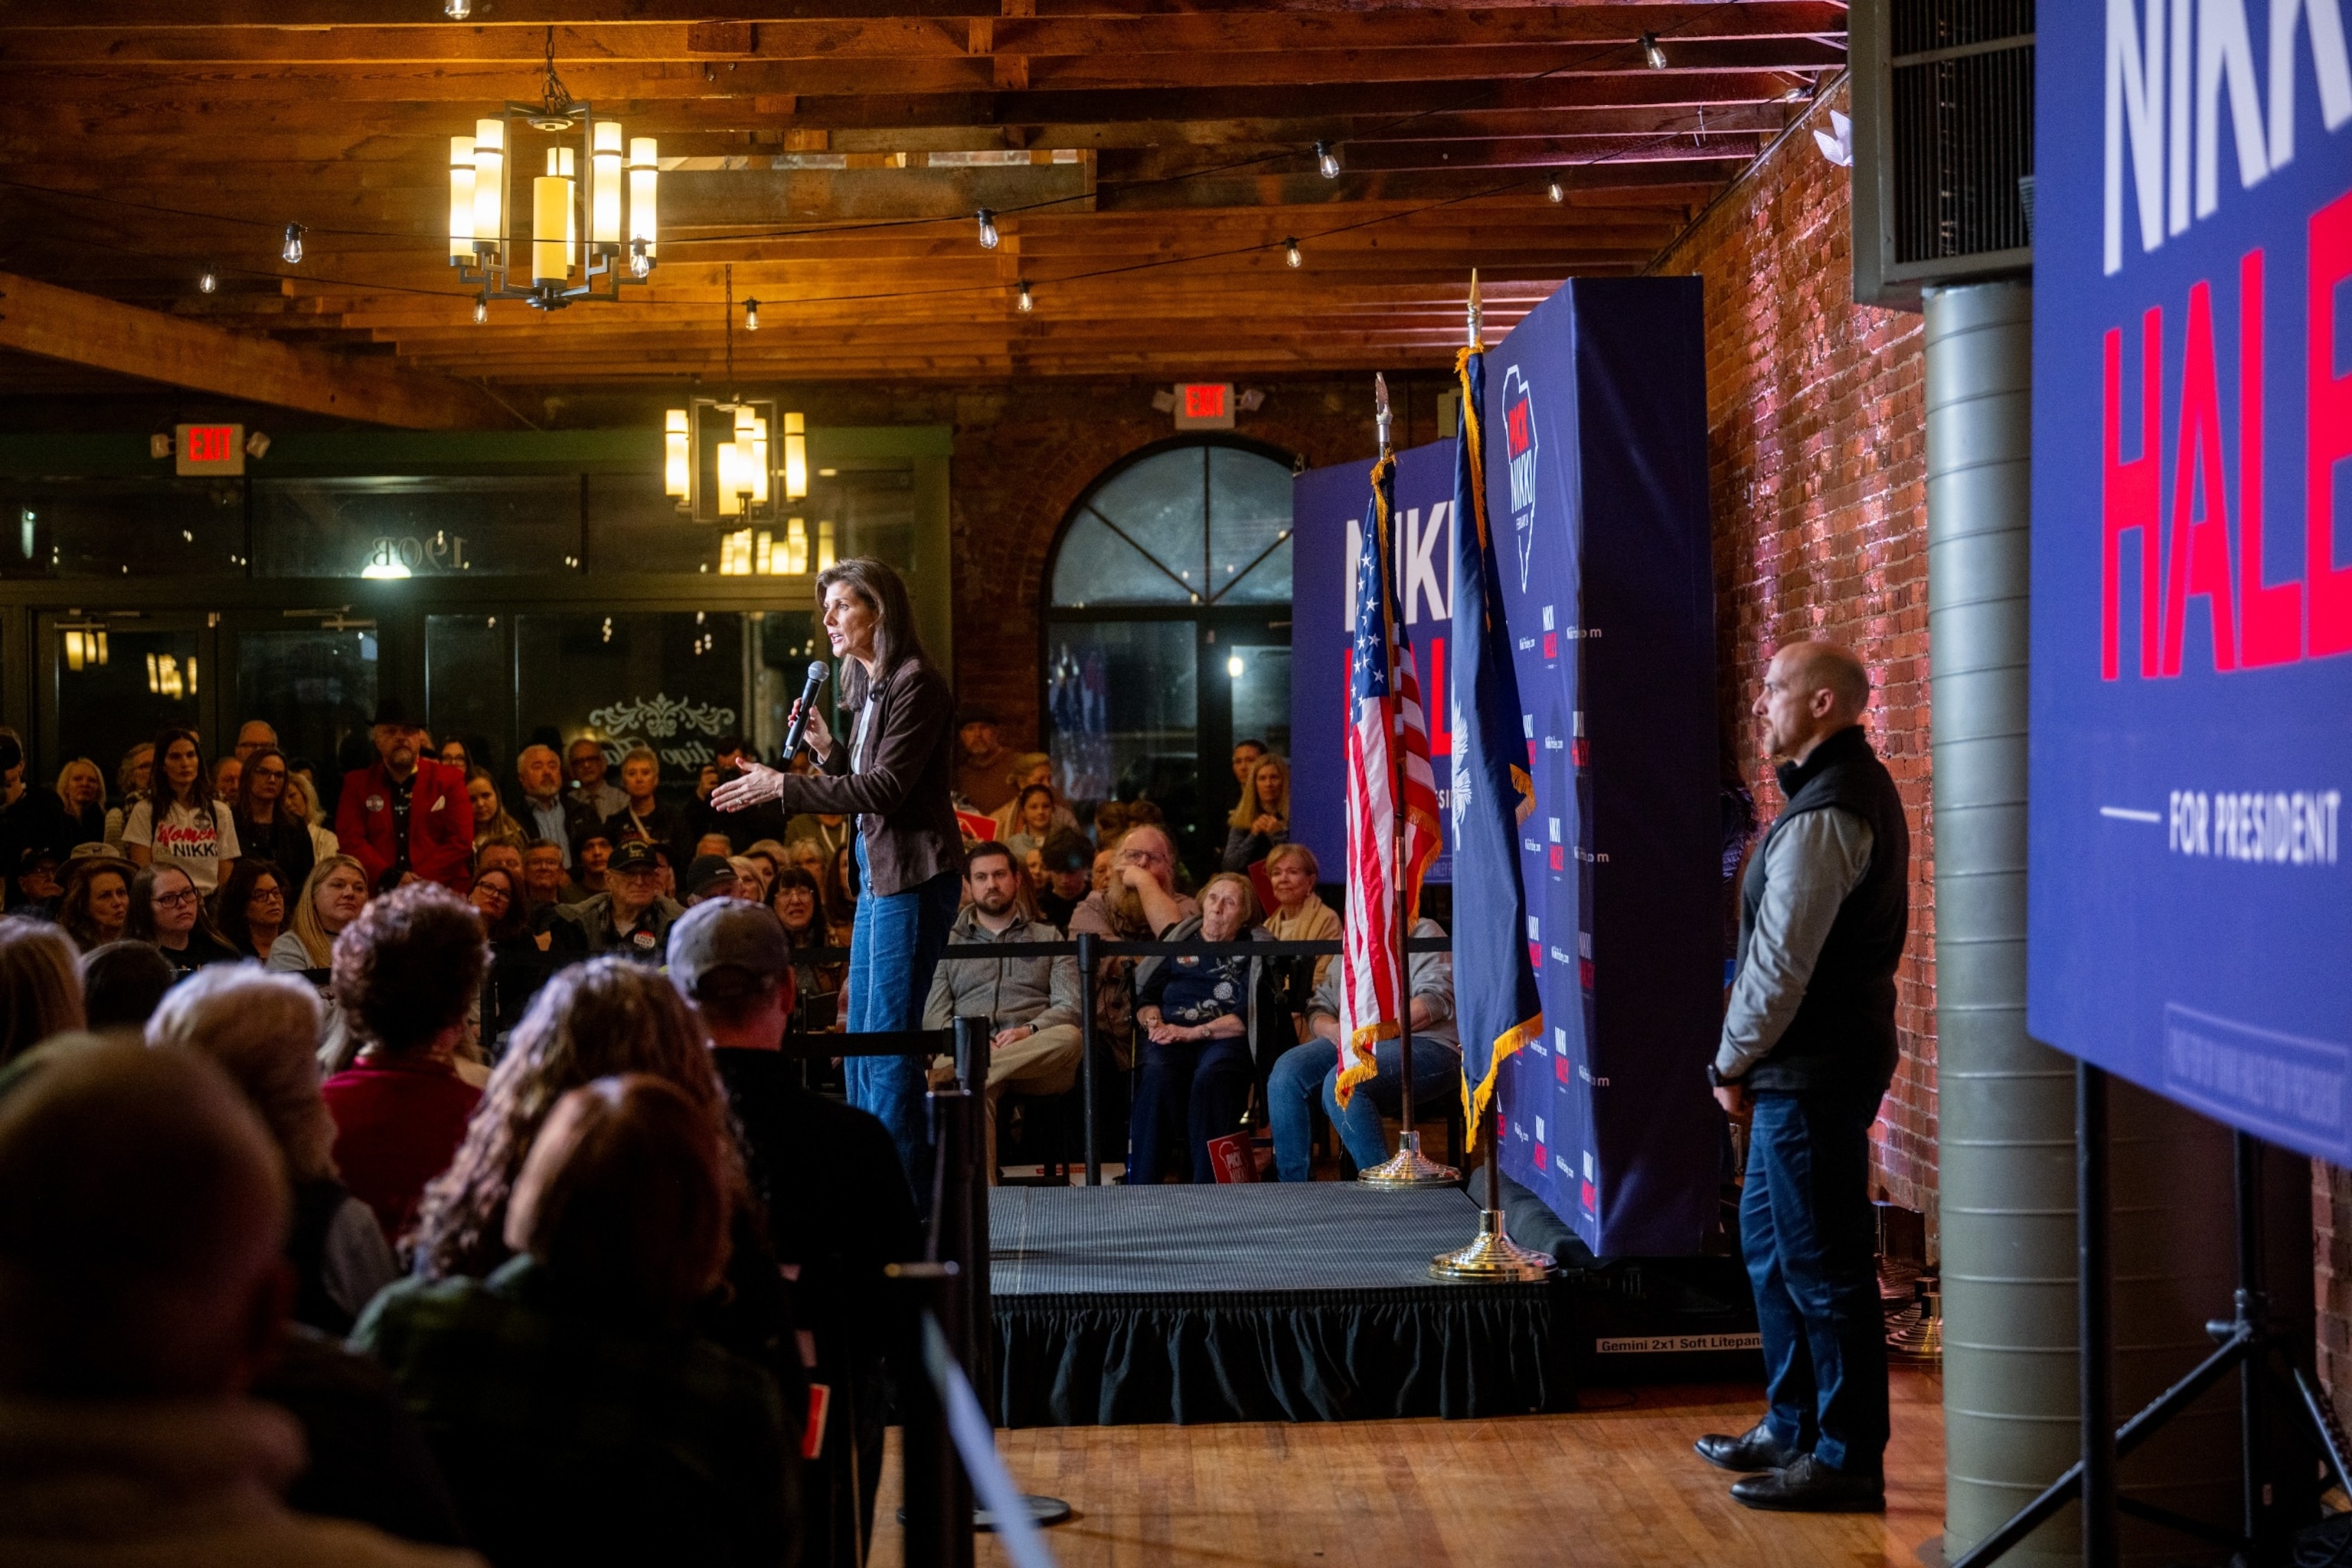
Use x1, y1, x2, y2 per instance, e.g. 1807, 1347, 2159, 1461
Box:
1740, 1093, 1886, 1476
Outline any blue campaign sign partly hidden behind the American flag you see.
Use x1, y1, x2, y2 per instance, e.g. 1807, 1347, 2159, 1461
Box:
1292, 439, 1453, 881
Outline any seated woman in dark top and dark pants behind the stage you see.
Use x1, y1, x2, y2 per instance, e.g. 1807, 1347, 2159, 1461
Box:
1126, 872, 1279, 1185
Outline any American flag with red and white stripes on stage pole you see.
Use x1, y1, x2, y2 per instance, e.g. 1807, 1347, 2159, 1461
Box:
1338, 454, 1439, 1105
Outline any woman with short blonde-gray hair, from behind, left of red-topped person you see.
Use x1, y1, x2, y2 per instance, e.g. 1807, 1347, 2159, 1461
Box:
145, 964, 397, 1335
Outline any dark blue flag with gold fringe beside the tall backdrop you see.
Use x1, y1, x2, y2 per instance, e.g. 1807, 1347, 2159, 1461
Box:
1451, 348, 1543, 1147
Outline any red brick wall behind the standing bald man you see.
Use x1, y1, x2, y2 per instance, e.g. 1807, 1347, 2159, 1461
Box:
1651, 90, 1936, 1236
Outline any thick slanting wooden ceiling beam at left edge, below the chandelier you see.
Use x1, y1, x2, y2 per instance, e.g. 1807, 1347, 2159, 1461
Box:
0, 273, 508, 430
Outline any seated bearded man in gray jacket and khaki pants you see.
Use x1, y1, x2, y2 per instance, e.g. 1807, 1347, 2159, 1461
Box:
922, 841, 1082, 1182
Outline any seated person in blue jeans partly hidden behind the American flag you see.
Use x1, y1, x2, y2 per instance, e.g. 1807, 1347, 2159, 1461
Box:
1266, 916, 1463, 1182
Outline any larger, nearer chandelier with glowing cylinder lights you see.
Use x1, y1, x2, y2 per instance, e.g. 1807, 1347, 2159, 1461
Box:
449, 28, 661, 320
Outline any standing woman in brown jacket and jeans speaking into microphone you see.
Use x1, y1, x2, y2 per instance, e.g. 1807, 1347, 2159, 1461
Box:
710, 557, 965, 1194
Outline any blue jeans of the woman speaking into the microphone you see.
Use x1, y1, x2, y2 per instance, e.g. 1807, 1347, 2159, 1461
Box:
842, 837, 962, 1213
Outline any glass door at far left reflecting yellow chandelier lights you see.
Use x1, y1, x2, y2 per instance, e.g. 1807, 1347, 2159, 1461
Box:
31, 611, 224, 804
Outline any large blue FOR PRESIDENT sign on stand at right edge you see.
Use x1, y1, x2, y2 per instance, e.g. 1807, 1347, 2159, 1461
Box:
2027, 0, 2352, 1161
